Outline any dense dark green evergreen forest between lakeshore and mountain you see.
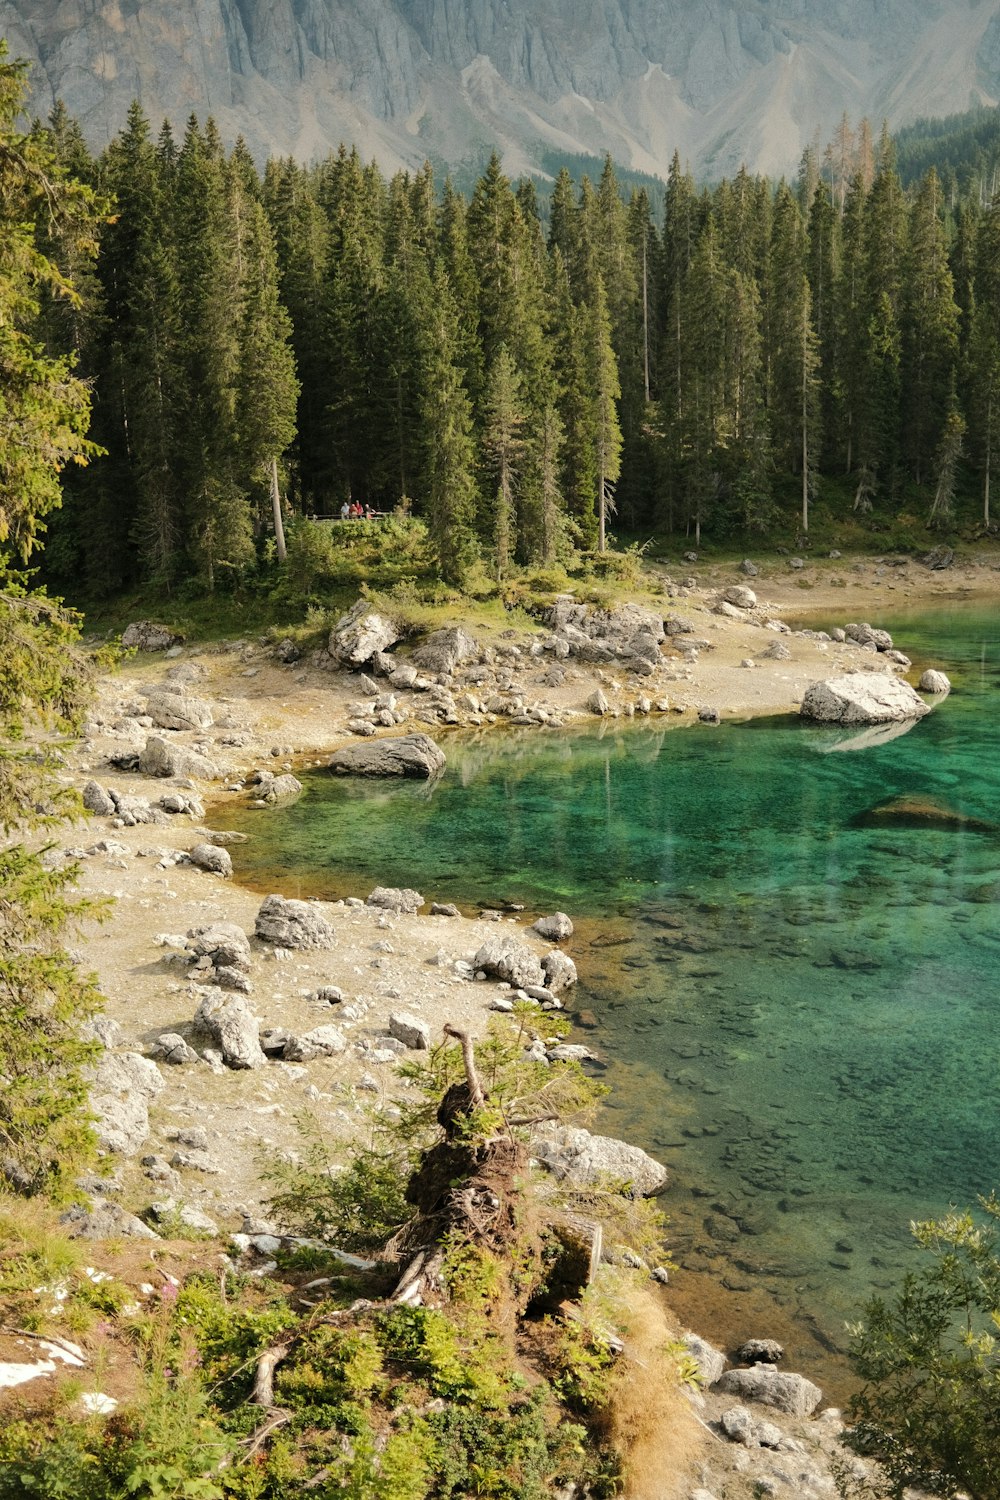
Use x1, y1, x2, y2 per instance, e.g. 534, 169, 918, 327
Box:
21, 95, 1000, 599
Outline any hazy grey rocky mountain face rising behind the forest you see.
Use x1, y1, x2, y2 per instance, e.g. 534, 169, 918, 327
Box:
0, 0, 1000, 176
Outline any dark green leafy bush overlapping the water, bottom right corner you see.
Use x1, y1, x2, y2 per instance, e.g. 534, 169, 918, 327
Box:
850, 1194, 1000, 1500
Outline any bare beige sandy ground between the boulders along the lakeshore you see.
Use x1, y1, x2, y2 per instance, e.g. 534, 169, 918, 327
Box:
52, 557, 1000, 1500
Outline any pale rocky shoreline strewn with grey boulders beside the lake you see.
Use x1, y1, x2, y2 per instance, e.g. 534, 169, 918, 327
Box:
49, 555, 991, 1500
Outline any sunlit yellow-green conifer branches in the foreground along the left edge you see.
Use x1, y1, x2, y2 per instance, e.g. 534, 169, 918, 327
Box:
0, 42, 99, 1193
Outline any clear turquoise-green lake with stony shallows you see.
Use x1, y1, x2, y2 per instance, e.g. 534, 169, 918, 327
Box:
229, 606, 1000, 1380
